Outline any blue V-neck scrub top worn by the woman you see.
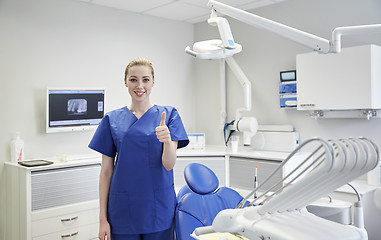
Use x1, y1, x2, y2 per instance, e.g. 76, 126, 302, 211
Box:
89, 105, 189, 234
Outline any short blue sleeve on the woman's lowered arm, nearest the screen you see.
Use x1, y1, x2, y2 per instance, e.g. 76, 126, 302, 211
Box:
89, 115, 116, 158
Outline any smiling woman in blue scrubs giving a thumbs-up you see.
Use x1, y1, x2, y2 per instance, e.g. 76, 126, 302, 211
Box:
89, 58, 189, 240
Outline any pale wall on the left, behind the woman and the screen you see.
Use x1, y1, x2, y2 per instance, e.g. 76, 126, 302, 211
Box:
0, 0, 195, 239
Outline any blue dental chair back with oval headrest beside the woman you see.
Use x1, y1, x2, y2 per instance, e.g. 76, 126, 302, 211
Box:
175, 163, 243, 240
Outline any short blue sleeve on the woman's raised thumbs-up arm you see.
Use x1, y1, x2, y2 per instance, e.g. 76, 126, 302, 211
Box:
168, 108, 189, 148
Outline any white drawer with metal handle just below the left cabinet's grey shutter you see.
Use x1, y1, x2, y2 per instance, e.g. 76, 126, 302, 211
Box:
32, 209, 99, 236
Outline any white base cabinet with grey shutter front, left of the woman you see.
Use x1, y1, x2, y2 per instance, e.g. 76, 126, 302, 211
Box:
5, 162, 101, 240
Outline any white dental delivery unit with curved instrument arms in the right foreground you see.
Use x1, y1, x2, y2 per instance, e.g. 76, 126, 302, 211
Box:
191, 138, 379, 240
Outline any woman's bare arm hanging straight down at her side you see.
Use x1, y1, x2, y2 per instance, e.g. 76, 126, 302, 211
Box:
99, 155, 114, 240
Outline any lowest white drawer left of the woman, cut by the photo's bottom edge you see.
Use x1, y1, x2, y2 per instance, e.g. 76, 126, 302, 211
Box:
32, 223, 98, 240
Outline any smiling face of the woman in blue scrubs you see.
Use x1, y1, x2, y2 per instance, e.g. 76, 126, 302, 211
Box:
125, 65, 154, 104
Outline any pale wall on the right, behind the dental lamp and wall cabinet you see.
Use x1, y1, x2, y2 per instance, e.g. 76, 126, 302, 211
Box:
195, 0, 381, 146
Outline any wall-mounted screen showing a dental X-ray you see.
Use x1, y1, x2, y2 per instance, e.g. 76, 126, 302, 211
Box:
46, 88, 105, 133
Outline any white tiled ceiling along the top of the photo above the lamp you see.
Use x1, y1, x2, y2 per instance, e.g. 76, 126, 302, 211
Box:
79, 0, 285, 23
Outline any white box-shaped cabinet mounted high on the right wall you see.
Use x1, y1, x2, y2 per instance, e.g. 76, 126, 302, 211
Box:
296, 45, 381, 114
